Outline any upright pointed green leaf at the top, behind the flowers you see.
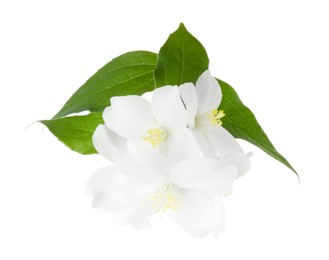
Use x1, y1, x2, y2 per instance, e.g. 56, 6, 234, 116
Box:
154, 24, 209, 87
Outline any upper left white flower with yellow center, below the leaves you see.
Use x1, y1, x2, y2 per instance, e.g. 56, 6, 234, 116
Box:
93, 86, 197, 160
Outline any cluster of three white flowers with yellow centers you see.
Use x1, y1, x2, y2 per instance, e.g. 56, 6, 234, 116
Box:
87, 71, 250, 237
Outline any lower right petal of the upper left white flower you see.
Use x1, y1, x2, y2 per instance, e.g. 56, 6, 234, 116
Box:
166, 127, 201, 162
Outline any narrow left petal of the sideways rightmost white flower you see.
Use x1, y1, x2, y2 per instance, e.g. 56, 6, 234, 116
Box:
179, 83, 198, 127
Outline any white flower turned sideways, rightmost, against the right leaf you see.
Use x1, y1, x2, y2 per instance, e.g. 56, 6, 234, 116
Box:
179, 70, 250, 176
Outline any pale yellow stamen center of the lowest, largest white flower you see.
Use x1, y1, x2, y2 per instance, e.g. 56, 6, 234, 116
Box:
148, 183, 179, 213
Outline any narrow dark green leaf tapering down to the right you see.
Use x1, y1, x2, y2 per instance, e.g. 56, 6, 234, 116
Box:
218, 80, 298, 176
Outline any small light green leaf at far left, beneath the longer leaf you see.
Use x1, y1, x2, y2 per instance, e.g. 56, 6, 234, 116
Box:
40, 113, 104, 154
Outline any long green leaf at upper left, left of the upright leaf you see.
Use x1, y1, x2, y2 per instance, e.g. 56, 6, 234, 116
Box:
54, 51, 157, 118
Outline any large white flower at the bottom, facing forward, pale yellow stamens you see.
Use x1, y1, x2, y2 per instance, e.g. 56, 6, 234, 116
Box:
87, 141, 237, 237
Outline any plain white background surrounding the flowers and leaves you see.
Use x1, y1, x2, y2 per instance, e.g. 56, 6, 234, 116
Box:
0, 0, 329, 260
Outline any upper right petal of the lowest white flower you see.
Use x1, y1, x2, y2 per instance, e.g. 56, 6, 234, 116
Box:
170, 159, 237, 196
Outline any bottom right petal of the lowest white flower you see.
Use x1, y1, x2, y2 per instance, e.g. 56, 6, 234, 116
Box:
168, 190, 225, 238
